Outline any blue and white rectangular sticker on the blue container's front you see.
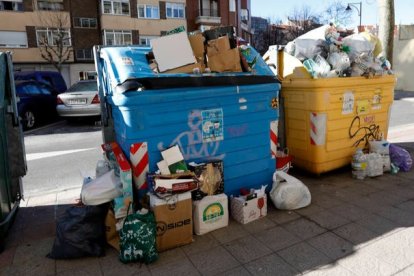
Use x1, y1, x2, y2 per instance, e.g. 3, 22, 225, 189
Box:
201, 108, 224, 142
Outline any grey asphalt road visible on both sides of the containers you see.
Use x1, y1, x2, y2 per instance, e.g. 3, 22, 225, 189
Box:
23, 91, 414, 196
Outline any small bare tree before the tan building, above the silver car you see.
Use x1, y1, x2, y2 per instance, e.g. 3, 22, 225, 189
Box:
37, 12, 73, 73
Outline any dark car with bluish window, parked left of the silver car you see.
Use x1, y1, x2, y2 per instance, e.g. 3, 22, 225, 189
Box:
15, 80, 58, 130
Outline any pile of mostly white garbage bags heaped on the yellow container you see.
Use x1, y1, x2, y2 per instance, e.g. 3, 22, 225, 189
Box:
285, 23, 393, 78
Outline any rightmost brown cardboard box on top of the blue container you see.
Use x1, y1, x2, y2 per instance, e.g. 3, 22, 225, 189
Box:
207, 48, 243, 72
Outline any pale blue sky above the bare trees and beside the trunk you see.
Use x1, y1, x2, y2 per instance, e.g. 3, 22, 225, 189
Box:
250, 0, 414, 26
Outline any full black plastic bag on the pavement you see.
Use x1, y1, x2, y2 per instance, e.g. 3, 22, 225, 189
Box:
47, 204, 108, 259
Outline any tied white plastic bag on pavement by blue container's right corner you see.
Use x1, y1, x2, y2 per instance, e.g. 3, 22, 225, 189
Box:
269, 171, 311, 210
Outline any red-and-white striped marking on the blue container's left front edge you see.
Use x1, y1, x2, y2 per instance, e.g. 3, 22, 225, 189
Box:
130, 142, 149, 190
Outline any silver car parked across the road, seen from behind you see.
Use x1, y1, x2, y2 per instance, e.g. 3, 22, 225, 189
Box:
56, 80, 101, 118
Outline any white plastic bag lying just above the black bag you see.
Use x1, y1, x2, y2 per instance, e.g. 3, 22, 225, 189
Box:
81, 170, 122, 205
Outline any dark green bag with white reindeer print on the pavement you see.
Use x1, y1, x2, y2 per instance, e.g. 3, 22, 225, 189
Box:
119, 207, 158, 264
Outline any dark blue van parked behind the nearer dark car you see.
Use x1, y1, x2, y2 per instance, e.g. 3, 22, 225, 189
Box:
14, 71, 67, 93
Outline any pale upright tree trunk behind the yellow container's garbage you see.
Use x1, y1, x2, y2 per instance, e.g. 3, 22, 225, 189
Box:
378, 0, 395, 64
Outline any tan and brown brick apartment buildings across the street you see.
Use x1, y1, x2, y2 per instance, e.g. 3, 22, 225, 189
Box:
0, 0, 251, 85
